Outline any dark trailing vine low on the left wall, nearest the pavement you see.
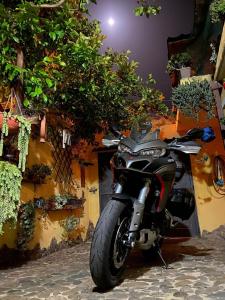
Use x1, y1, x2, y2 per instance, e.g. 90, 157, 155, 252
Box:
17, 201, 35, 250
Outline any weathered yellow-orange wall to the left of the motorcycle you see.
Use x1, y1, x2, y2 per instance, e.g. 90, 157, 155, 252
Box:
0, 139, 99, 249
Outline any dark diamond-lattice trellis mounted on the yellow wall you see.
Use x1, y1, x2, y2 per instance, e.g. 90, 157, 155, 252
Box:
48, 127, 76, 193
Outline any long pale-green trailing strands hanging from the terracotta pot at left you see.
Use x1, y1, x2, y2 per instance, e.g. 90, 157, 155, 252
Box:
0, 112, 31, 172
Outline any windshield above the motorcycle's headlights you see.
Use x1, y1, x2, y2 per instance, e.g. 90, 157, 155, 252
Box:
130, 122, 159, 143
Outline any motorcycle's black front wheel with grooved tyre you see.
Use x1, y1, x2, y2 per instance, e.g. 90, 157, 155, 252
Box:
90, 200, 132, 290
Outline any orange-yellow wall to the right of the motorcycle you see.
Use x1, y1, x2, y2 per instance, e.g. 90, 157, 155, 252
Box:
177, 113, 225, 232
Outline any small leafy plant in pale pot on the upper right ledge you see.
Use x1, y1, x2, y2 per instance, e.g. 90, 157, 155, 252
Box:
166, 52, 191, 78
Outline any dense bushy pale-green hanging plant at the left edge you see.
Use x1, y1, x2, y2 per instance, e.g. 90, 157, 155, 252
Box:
0, 161, 22, 234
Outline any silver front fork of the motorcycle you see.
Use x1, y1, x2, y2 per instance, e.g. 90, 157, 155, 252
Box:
115, 180, 151, 248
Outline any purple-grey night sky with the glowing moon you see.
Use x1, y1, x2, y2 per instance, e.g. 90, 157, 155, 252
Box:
90, 0, 195, 98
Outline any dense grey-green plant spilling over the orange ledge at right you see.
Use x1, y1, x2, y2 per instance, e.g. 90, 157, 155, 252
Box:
172, 80, 215, 119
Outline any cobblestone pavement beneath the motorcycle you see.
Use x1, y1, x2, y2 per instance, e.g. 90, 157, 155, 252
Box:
0, 228, 225, 300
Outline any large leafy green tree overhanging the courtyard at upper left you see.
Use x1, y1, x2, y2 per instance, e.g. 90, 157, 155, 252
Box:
0, 0, 166, 138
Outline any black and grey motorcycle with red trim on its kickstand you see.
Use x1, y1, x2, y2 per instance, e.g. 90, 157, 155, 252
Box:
90, 124, 215, 290
